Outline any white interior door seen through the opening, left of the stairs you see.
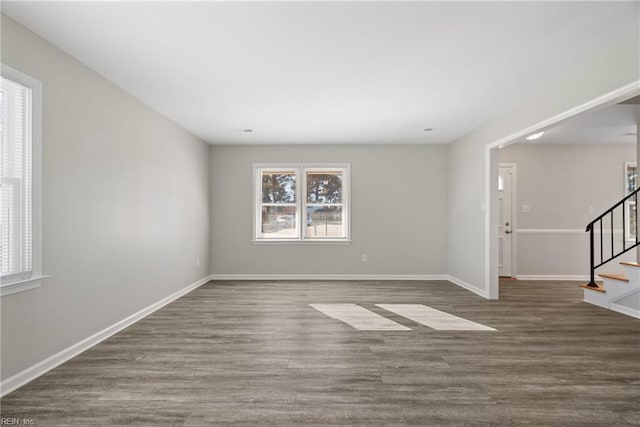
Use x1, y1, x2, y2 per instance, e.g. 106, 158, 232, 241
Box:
498, 165, 514, 277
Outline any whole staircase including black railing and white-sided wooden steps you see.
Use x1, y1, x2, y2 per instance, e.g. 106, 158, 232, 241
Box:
581, 189, 640, 319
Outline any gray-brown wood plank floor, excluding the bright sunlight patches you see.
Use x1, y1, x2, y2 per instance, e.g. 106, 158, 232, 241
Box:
1, 281, 640, 426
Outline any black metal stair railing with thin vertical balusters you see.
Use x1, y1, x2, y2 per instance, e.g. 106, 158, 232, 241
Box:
586, 188, 640, 288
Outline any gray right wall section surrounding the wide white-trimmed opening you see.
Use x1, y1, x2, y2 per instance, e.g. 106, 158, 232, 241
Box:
447, 3, 640, 297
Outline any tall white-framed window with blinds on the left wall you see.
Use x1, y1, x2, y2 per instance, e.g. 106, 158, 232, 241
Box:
0, 65, 43, 295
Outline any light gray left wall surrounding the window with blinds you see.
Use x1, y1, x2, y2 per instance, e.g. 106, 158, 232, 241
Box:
1, 15, 209, 379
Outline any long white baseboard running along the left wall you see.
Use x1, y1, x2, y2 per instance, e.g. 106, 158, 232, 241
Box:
0, 276, 211, 397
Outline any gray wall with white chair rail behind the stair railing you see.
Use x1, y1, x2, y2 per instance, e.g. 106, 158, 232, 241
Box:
499, 144, 636, 276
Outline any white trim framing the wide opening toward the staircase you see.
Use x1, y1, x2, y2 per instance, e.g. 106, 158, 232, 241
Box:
484, 79, 640, 299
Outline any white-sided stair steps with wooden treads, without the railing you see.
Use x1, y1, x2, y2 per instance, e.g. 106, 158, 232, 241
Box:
580, 262, 640, 319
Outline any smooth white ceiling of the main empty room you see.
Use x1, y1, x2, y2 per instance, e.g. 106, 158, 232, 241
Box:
2, 1, 638, 144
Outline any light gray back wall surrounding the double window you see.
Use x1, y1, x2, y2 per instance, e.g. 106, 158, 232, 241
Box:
211, 145, 447, 276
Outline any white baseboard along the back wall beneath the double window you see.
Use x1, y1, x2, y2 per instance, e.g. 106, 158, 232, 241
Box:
210, 274, 448, 281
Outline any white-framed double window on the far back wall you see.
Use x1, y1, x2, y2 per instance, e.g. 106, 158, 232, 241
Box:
254, 164, 350, 241
